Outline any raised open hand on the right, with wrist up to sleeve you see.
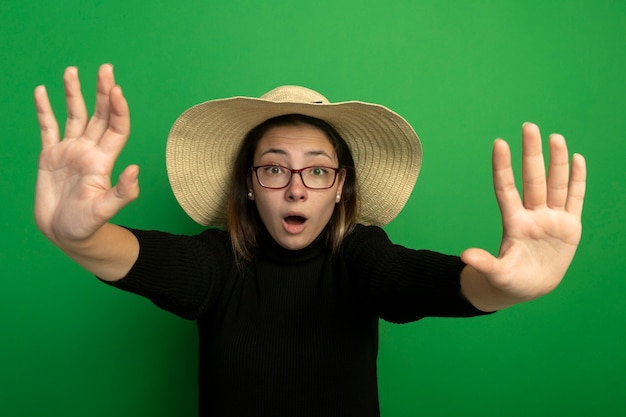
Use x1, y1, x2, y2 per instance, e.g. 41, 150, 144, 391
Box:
461, 123, 586, 311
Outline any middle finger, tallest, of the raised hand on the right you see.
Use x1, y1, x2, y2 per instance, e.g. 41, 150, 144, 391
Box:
522, 123, 546, 209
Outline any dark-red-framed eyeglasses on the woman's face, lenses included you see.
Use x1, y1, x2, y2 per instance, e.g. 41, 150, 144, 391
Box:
252, 165, 339, 190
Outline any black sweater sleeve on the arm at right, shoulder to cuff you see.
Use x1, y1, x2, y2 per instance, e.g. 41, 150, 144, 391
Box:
345, 226, 492, 323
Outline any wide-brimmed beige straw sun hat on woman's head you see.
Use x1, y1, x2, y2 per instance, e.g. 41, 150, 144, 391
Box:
166, 86, 422, 227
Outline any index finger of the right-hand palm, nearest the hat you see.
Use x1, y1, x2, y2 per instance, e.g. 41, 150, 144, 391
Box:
492, 139, 522, 220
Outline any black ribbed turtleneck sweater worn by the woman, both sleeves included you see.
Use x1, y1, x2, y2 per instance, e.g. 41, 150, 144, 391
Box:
106, 226, 482, 417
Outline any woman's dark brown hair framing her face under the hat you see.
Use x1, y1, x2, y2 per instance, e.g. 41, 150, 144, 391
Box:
226, 114, 358, 260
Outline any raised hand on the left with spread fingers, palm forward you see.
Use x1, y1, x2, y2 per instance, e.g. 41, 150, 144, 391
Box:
35, 64, 139, 244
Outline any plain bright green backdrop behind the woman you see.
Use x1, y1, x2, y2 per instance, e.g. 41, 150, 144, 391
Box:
0, 0, 626, 417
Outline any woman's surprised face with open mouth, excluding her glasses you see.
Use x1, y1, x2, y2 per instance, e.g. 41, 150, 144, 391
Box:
249, 125, 345, 250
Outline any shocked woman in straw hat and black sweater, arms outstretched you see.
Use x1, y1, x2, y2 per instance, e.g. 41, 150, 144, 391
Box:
35, 65, 585, 416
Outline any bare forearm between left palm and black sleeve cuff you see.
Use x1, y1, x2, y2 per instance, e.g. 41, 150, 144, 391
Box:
53, 223, 139, 281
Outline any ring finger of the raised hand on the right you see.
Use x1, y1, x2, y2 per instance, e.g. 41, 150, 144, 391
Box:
547, 134, 569, 209
